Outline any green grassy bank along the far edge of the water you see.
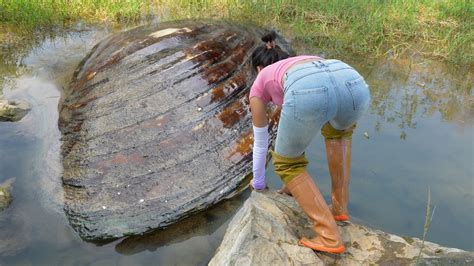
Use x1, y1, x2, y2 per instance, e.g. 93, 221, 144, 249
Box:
0, 0, 474, 66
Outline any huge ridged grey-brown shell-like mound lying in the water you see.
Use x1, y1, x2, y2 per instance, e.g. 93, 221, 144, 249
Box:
59, 21, 290, 240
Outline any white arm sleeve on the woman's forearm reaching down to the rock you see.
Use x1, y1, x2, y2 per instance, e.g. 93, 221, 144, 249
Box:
252, 125, 269, 189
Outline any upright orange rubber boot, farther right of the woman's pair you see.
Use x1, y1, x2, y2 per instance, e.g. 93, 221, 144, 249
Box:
326, 139, 352, 221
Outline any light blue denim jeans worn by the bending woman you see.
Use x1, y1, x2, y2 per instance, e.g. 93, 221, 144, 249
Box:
275, 60, 370, 158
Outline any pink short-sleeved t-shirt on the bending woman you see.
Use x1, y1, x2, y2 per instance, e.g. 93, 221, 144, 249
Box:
249, 55, 321, 106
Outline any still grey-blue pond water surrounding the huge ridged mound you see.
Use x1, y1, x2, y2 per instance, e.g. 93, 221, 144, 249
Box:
0, 26, 474, 265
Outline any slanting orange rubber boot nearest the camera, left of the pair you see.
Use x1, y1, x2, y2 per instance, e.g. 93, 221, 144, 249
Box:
286, 171, 345, 254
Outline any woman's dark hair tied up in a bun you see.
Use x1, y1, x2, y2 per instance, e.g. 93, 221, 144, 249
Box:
252, 31, 289, 69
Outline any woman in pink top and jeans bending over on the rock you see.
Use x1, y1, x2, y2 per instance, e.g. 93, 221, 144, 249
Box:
249, 32, 370, 253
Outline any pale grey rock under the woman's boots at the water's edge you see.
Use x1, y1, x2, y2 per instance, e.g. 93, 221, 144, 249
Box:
209, 191, 474, 265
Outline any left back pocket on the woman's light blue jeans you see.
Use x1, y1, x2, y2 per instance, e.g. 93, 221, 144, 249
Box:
292, 87, 328, 122
